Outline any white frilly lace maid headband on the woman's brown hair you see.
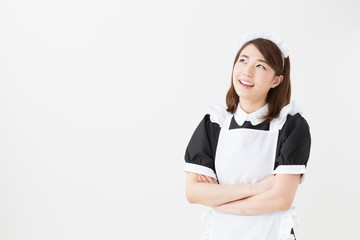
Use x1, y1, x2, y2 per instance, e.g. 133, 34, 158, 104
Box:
240, 32, 289, 67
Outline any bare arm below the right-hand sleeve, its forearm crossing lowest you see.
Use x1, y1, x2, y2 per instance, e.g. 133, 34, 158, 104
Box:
214, 175, 300, 215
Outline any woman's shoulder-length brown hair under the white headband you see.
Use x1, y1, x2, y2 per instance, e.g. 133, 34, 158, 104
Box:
226, 38, 291, 123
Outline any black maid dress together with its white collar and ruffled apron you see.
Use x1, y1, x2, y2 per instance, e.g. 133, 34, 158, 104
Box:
184, 102, 311, 240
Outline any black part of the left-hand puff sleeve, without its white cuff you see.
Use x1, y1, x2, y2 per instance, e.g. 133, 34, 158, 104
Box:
185, 114, 221, 173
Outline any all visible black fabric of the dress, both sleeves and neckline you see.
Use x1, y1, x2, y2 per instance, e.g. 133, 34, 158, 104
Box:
185, 113, 311, 173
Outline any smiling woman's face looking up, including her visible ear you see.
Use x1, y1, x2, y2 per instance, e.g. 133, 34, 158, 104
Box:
233, 44, 283, 105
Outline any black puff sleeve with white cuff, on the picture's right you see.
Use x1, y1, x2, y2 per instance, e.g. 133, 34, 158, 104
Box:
273, 113, 311, 183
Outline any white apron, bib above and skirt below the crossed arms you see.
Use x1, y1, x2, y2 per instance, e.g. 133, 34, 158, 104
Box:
201, 115, 296, 240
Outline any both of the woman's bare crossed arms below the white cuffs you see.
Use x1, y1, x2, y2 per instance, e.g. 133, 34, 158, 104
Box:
186, 173, 300, 215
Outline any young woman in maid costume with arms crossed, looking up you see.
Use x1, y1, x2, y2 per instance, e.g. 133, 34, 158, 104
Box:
184, 32, 311, 240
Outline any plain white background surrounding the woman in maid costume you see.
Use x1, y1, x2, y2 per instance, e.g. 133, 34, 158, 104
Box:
0, 0, 360, 240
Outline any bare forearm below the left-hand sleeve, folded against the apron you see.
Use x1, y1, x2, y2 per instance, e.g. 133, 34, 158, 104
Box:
186, 182, 256, 207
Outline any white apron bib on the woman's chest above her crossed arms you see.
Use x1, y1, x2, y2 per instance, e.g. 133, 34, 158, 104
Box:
215, 116, 279, 185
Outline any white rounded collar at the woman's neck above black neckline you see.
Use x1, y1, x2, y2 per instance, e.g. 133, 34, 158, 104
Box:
234, 103, 268, 126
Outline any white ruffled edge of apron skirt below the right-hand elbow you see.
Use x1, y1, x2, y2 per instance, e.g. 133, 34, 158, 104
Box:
279, 206, 298, 240
